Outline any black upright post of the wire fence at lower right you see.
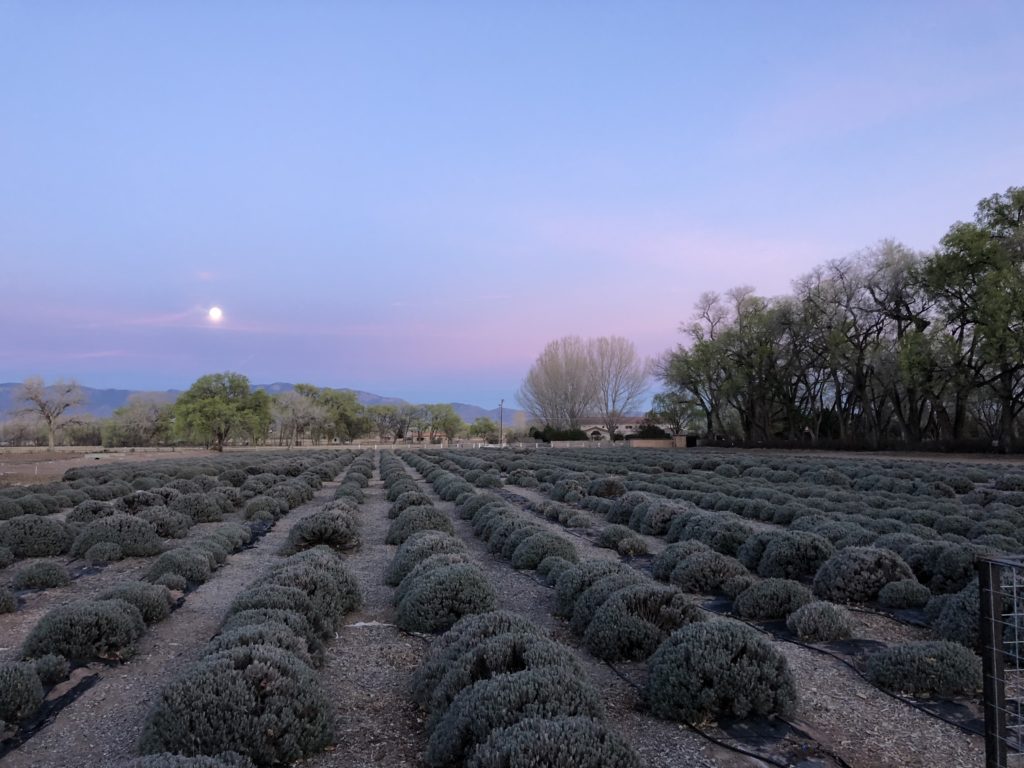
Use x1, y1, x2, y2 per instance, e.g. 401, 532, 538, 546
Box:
978, 560, 1007, 768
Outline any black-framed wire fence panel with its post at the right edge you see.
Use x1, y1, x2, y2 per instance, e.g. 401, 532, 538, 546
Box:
978, 557, 1024, 768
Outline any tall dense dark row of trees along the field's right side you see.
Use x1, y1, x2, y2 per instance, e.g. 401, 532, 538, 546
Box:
654, 187, 1024, 452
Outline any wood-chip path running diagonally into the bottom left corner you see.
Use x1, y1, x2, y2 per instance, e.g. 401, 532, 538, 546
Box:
3, 482, 337, 768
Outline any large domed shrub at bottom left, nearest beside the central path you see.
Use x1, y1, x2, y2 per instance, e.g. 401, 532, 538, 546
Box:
139, 645, 333, 766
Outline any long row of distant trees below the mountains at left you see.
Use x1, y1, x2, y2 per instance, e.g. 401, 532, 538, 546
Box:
0, 372, 515, 450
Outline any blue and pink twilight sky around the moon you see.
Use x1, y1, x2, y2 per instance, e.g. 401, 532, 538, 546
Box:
0, 0, 1024, 408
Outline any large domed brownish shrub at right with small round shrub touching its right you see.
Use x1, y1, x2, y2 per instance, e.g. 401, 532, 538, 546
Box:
814, 547, 913, 603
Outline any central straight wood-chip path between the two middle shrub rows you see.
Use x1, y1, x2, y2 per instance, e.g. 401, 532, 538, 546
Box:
302, 454, 428, 768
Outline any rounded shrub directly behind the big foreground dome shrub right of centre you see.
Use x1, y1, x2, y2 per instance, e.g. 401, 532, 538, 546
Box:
584, 584, 703, 662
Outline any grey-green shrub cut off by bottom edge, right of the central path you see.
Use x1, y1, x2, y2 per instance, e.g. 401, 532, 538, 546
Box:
466, 717, 640, 768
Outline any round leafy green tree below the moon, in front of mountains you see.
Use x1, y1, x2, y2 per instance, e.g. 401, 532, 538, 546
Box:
174, 372, 270, 451
